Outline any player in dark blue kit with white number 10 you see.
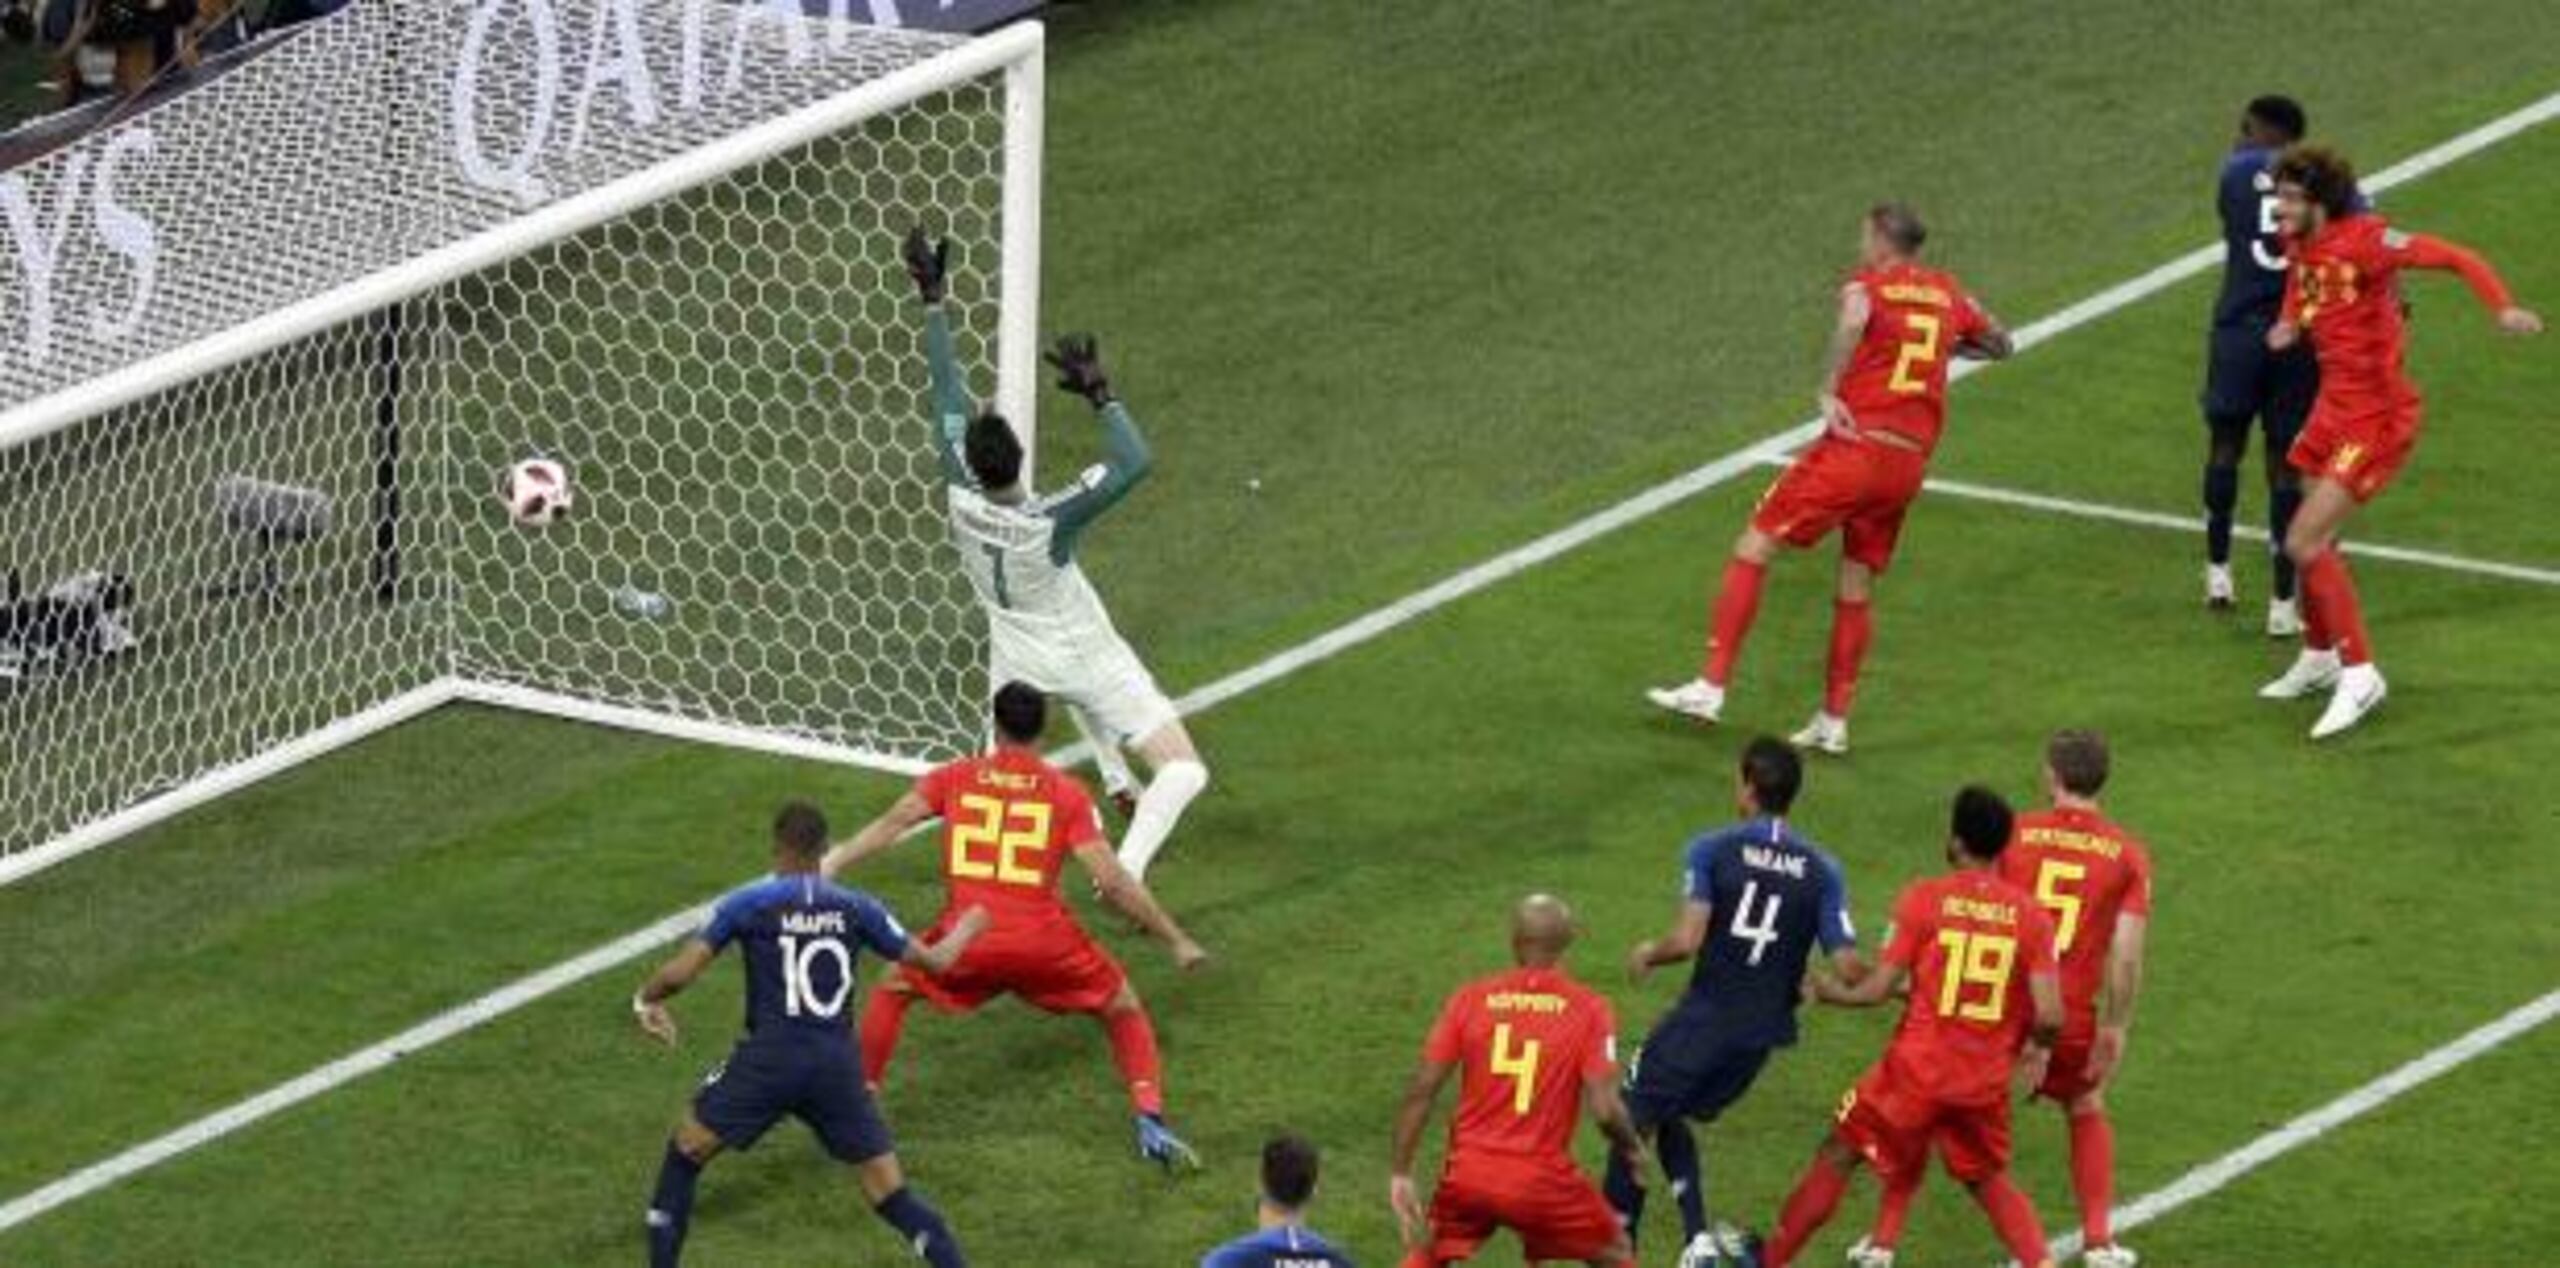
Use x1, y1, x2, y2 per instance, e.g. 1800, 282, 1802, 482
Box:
632, 802, 988, 1268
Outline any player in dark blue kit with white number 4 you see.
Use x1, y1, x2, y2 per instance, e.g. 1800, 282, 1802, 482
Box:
1605, 735, 1866, 1268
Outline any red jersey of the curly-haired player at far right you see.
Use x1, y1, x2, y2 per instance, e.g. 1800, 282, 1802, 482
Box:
2284, 213, 2514, 415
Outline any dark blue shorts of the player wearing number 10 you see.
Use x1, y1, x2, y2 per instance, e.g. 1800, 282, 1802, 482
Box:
694, 1037, 893, 1163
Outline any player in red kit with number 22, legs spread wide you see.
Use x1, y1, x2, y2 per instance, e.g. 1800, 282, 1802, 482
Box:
824, 681, 1208, 1171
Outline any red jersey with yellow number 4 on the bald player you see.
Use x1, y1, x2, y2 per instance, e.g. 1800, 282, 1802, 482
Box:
1423, 968, 1618, 1158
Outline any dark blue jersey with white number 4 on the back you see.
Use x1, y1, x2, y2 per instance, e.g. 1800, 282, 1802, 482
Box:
1684, 817, 1859, 1045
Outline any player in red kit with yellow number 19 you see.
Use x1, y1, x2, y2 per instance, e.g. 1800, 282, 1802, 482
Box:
1761, 786, 2063, 1268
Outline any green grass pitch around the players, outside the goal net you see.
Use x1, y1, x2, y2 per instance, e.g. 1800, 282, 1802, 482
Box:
0, 0, 2560, 1268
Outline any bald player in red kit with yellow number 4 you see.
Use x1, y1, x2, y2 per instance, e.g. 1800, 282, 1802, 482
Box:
1388, 894, 1646, 1268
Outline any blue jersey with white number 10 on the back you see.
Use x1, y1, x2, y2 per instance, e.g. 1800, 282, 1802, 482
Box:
701, 874, 906, 1043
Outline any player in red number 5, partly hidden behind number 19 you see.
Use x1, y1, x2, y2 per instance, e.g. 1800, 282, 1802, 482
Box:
1851, 730, 2150, 1268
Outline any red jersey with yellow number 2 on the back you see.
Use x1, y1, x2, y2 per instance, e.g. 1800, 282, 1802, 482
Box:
1838, 264, 1992, 448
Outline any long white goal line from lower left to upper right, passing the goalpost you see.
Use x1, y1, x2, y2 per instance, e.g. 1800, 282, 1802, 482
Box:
0, 92, 2560, 1232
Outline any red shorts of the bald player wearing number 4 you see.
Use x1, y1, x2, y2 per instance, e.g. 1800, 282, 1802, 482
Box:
1405, 1153, 1618, 1268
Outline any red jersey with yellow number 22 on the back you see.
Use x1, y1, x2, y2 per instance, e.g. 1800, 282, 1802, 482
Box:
916, 748, 1101, 925
